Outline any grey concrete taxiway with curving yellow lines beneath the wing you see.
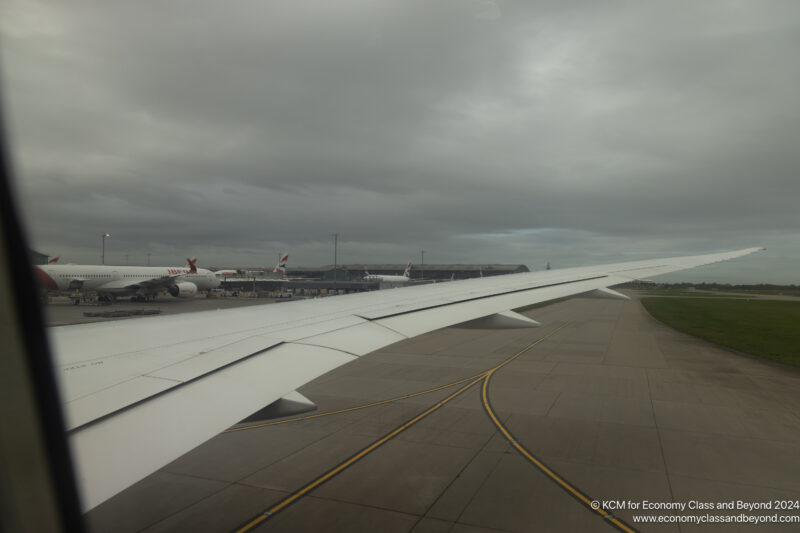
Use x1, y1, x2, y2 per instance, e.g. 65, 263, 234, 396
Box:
87, 299, 800, 533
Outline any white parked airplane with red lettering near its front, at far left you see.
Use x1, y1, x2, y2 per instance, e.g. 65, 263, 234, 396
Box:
34, 259, 220, 301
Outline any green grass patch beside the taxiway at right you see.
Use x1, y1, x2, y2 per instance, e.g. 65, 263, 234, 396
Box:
642, 298, 800, 366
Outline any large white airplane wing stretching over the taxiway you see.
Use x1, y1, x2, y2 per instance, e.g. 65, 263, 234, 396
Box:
48, 248, 760, 510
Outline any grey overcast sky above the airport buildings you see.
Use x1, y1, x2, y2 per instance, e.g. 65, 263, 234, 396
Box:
0, 0, 800, 283
